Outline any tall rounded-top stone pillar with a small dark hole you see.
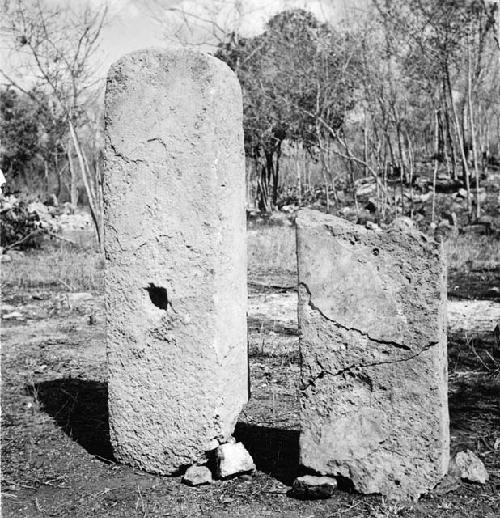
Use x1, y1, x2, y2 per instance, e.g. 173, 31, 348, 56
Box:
104, 49, 248, 474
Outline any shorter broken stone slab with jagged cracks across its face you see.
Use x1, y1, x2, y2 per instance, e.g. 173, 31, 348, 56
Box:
296, 210, 449, 499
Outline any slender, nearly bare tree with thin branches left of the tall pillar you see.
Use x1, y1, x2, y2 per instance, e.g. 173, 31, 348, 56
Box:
0, 0, 107, 248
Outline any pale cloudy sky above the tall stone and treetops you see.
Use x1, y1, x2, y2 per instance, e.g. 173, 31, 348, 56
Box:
0, 0, 368, 86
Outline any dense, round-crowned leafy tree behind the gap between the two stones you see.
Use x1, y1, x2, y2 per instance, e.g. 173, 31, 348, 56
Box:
216, 9, 356, 211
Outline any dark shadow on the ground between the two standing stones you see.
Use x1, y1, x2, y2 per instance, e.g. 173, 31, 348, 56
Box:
235, 423, 299, 485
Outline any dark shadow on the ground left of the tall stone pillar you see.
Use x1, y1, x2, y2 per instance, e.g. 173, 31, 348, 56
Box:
28, 378, 113, 461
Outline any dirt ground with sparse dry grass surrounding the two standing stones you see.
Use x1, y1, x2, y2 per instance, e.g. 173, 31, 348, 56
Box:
1, 233, 500, 518
